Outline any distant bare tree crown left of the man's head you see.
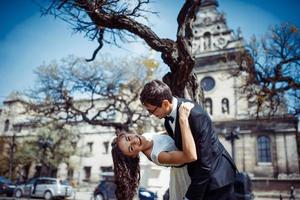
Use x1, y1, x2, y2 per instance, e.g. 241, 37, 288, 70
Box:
27, 56, 159, 130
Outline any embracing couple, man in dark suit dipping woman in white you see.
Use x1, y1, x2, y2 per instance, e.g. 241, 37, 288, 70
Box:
112, 80, 236, 200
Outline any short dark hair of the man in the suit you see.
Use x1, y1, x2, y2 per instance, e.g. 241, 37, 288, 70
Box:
140, 80, 173, 106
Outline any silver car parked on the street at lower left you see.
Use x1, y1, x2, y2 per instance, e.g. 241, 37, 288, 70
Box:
15, 177, 74, 200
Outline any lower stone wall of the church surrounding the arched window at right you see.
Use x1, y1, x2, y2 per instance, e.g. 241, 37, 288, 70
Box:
215, 121, 300, 179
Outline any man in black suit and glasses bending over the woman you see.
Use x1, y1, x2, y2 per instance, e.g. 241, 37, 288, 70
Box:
140, 80, 236, 200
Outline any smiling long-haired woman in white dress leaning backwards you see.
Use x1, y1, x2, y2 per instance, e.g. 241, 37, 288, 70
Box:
112, 102, 197, 200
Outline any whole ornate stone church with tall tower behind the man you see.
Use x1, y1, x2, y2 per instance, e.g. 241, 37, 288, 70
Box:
193, 0, 300, 197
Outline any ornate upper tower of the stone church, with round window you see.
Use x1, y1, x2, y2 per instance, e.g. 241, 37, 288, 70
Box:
192, 0, 249, 121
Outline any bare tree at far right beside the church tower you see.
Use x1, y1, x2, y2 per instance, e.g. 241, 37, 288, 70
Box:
234, 23, 300, 117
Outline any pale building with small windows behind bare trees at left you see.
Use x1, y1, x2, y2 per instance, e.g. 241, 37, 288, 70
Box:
0, 98, 115, 184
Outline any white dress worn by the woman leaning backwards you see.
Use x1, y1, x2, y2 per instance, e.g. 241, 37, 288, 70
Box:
145, 134, 191, 200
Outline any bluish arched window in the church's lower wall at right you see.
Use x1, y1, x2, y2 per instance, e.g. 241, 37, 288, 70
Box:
257, 136, 271, 162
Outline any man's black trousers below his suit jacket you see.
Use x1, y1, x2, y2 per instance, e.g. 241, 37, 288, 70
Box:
204, 183, 236, 200
